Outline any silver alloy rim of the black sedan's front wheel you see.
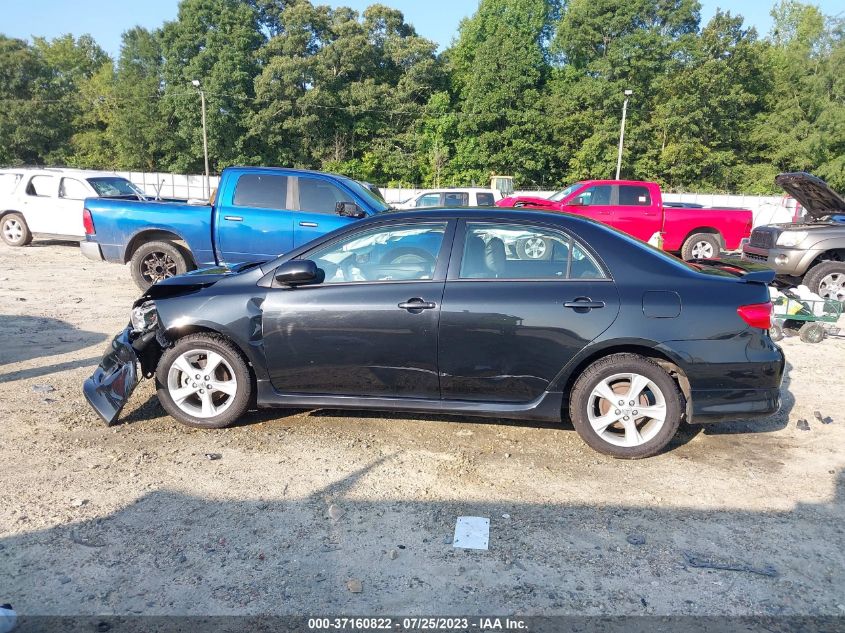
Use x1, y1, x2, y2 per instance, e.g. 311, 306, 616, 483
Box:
167, 349, 238, 418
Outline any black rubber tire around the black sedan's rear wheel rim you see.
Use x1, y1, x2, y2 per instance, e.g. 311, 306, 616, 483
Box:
569, 354, 685, 459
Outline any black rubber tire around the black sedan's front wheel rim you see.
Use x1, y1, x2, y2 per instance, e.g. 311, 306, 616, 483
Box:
156, 334, 253, 429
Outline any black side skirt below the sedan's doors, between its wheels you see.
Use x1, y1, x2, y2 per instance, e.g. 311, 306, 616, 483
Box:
256, 380, 563, 422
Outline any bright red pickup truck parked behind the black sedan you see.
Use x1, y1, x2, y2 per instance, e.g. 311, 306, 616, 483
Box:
496, 180, 752, 260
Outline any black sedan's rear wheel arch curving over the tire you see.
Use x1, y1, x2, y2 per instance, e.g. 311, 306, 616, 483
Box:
554, 341, 692, 420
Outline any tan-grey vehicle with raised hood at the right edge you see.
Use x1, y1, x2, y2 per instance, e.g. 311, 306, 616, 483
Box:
742, 172, 845, 301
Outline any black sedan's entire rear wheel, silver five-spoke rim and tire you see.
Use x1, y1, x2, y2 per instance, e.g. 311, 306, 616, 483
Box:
569, 354, 684, 459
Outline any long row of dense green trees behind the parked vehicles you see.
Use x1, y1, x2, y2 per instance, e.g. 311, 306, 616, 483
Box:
0, 0, 845, 193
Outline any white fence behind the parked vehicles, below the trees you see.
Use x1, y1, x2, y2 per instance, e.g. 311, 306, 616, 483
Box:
117, 171, 792, 226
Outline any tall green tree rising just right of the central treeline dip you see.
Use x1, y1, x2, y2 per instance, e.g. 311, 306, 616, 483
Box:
446, 0, 557, 183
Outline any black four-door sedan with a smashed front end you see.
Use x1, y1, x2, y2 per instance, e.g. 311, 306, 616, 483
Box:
84, 208, 784, 458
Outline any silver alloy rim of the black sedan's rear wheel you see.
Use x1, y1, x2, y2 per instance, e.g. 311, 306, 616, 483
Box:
587, 373, 667, 447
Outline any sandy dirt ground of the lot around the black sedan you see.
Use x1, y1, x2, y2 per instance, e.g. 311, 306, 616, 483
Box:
0, 242, 845, 616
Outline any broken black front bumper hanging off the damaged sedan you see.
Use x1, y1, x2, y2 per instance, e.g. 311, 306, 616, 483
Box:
82, 326, 162, 425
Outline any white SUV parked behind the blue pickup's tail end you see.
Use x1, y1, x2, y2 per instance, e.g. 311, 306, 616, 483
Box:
0, 167, 146, 246
